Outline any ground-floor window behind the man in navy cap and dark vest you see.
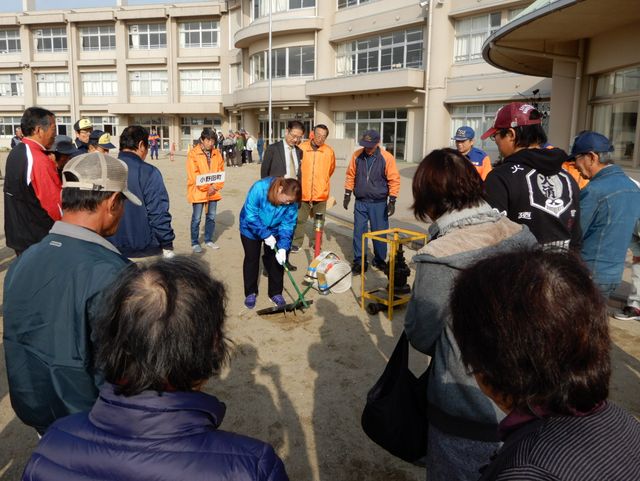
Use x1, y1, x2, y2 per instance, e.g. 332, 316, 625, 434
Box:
336, 109, 407, 160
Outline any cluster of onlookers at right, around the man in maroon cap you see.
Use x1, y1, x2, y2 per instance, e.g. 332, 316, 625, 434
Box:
404, 103, 640, 480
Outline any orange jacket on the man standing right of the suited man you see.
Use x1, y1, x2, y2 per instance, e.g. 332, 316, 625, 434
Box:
299, 140, 336, 202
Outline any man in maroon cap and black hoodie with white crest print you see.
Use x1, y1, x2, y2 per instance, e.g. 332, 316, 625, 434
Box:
482, 102, 580, 251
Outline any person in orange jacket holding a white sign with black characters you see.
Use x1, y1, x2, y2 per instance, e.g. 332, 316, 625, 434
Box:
187, 127, 224, 254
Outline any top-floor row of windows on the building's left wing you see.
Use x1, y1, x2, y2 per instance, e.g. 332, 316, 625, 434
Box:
0, 20, 220, 54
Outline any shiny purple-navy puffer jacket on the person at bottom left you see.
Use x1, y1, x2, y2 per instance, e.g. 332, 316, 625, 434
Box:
22, 384, 288, 481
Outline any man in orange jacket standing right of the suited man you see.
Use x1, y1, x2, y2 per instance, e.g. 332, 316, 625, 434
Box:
291, 124, 336, 252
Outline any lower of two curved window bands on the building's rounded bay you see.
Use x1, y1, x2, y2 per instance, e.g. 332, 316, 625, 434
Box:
250, 45, 315, 83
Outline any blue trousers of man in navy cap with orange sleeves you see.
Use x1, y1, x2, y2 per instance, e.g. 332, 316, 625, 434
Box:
353, 199, 389, 264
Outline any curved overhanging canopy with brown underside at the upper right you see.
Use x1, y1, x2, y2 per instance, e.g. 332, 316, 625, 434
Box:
482, 0, 640, 77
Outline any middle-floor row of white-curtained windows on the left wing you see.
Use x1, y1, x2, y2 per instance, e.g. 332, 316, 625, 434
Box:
0, 69, 222, 97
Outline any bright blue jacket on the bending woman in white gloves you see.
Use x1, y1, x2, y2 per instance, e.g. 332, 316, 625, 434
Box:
240, 177, 298, 251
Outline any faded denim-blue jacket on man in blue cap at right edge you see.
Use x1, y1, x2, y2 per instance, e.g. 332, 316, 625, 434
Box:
580, 165, 640, 284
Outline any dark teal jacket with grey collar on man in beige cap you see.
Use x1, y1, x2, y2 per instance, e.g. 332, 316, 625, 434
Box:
4, 222, 129, 433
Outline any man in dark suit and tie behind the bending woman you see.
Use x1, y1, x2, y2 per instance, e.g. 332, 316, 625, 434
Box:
260, 120, 304, 180
